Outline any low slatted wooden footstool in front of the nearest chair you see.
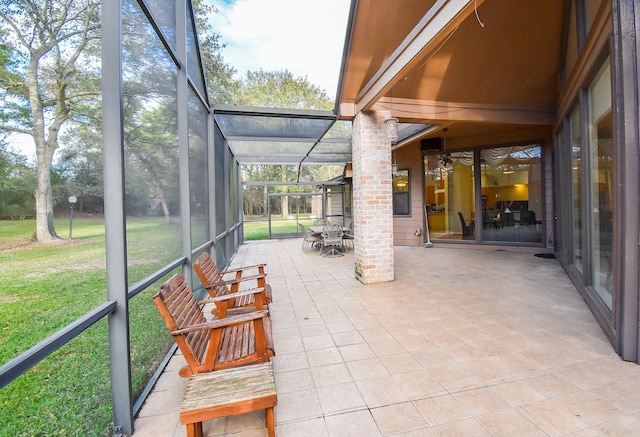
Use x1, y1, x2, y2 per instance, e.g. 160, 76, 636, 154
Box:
180, 361, 278, 437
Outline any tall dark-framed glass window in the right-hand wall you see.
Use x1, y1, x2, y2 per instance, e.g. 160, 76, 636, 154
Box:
557, 54, 615, 311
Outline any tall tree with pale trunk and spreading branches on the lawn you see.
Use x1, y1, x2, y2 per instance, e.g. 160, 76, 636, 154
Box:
0, 0, 100, 241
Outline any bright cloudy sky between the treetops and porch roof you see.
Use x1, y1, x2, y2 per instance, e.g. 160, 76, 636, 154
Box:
211, 0, 350, 98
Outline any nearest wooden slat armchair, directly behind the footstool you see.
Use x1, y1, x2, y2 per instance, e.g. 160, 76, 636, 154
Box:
153, 274, 274, 377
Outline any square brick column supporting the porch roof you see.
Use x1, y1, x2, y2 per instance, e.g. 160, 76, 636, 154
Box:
352, 111, 394, 284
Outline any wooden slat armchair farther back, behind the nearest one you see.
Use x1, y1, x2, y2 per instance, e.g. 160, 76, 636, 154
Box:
193, 252, 271, 317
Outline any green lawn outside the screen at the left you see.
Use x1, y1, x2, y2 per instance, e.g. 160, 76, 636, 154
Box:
0, 219, 180, 436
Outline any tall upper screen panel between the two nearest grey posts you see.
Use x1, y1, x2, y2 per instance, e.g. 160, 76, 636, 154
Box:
122, 1, 181, 283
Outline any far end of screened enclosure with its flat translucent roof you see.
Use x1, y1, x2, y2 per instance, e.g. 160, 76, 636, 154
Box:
213, 105, 351, 238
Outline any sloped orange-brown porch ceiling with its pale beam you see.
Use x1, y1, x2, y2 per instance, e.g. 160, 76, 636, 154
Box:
336, 0, 568, 150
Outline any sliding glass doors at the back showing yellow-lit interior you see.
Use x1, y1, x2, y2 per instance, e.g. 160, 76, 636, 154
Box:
425, 144, 544, 243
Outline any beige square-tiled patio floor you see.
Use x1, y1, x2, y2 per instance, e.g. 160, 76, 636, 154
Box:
134, 239, 640, 437
